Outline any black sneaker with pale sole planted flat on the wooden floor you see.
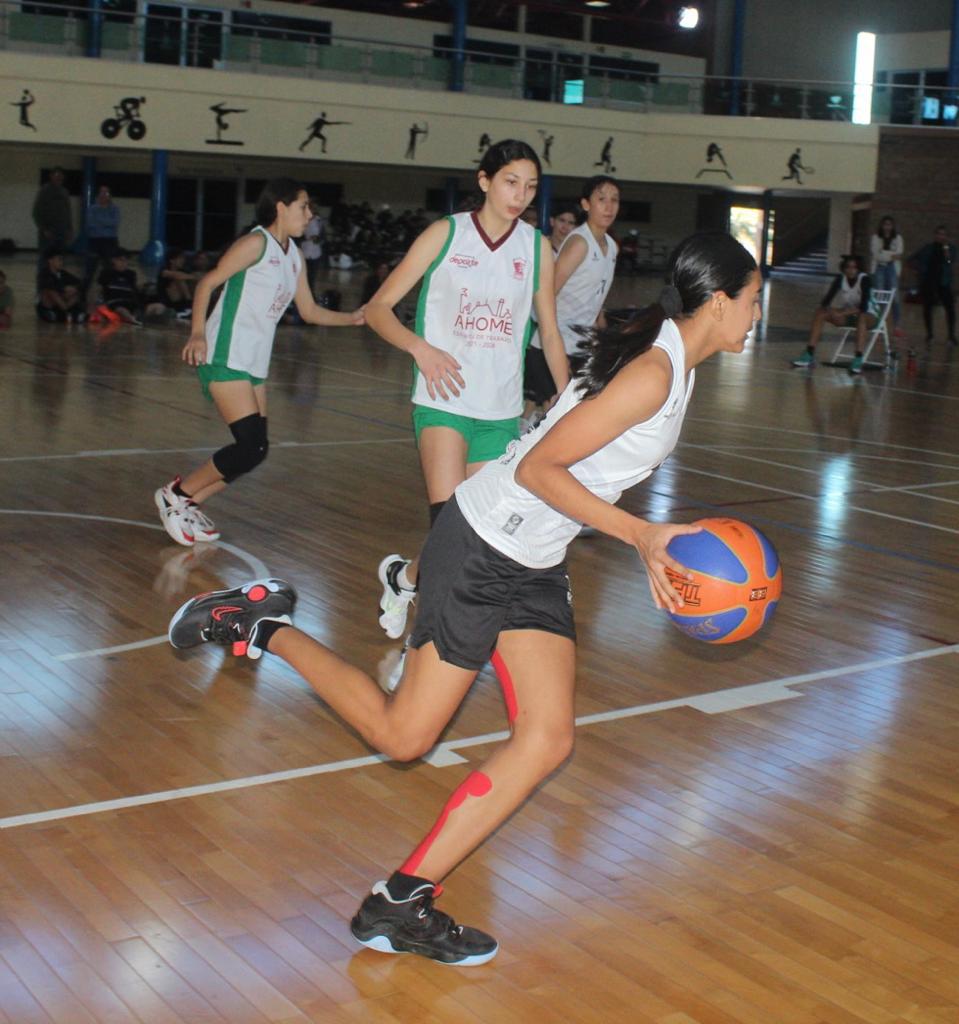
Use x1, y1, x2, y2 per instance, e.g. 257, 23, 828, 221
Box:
350, 871, 499, 967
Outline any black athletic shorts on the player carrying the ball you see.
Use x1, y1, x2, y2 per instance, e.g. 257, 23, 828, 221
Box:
409, 497, 576, 671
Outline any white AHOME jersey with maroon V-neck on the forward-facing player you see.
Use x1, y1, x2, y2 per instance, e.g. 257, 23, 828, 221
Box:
412, 213, 540, 420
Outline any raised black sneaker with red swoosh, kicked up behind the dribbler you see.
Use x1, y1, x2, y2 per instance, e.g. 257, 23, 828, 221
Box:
167, 580, 297, 660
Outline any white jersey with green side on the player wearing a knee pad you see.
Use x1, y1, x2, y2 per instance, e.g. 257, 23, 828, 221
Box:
207, 227, 301, 378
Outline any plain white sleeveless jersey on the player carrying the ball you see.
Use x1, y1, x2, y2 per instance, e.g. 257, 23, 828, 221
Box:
455, 319, 695, 569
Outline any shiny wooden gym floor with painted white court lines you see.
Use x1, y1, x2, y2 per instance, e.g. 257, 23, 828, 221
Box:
0, 249, 959, 1024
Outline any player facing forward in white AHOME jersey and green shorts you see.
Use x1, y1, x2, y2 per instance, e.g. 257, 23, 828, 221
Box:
366, 139, 569, 639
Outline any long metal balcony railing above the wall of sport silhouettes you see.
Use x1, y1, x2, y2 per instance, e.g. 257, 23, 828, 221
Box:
0, 0, 959, 125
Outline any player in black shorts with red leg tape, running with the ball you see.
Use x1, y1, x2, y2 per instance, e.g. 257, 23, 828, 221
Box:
170, 234, 760, 966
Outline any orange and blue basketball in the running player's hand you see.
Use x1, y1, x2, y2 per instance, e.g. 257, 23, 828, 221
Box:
666, 519, 783, 643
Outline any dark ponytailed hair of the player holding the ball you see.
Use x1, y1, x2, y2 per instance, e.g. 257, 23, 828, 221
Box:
576, 231, 756, 398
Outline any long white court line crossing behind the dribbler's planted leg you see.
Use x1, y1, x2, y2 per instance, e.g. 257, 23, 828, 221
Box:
0, 644, 959, 828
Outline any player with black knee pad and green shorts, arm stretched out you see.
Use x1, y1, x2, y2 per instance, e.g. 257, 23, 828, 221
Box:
154, 178, 363, 547
